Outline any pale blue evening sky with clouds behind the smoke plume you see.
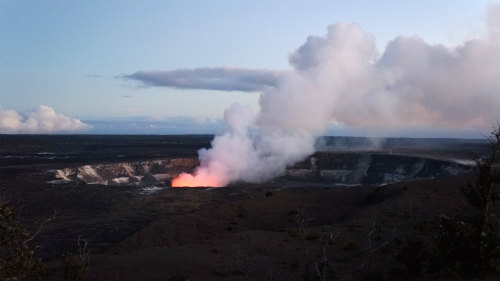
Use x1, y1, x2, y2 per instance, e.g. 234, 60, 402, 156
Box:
0, 0, 499, 138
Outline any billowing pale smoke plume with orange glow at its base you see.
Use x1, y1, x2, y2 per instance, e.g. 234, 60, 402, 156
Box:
173, 5, 500, 186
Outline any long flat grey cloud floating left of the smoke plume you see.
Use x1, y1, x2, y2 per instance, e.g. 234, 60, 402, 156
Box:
122, 67, 283, 92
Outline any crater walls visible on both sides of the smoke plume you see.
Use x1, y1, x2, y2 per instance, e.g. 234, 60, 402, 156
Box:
49, 152, 473, 187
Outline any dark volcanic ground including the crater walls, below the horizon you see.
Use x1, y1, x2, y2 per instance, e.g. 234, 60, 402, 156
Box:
0, 135, 490, 280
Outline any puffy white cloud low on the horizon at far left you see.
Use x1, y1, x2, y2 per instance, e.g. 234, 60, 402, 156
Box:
0, 105, 90, 134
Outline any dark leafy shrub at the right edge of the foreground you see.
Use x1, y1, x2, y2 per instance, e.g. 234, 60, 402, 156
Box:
433, 128, 500, 277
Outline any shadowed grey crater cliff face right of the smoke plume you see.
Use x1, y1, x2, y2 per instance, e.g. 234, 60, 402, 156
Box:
280, 153, 474, 185
